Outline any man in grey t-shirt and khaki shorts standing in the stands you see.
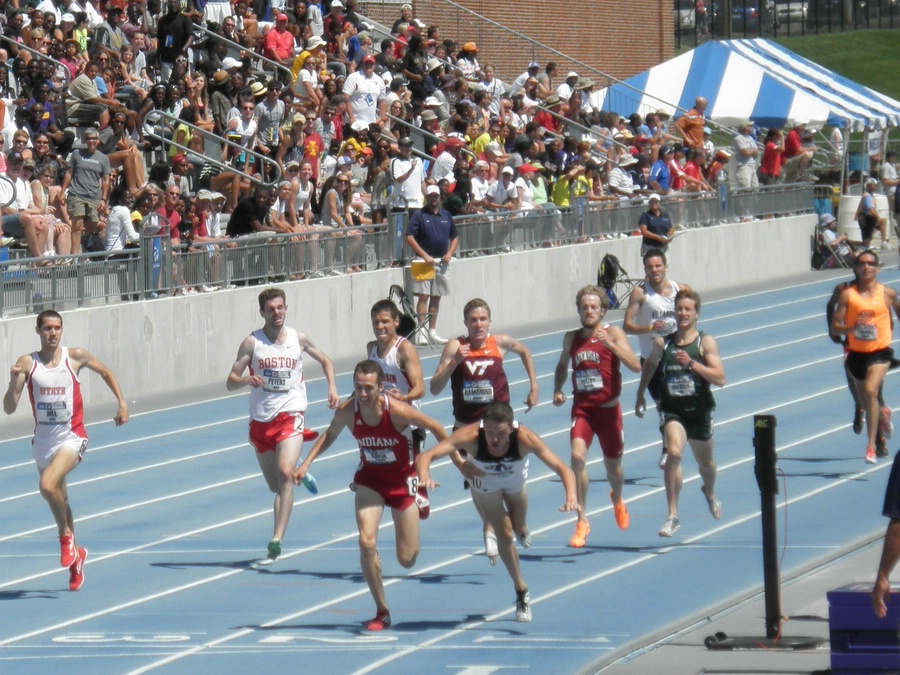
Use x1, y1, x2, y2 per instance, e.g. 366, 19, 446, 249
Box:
62, 129, 111, 254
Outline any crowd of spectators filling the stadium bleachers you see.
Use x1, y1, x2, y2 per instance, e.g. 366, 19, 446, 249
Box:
0, 0, 840, 282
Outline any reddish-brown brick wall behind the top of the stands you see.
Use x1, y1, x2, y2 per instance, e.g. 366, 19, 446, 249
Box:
359, 0, 675, 86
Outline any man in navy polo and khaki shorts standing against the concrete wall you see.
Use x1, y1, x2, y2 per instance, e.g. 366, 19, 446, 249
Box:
406, 185, 459, 345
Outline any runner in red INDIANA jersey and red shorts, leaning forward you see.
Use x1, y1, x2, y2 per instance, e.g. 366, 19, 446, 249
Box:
294, 360, 450, 631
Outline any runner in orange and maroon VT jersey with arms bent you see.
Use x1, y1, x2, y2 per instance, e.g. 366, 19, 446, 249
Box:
430, 298, 538, 565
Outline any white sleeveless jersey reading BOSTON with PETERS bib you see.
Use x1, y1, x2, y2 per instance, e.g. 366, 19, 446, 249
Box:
250, 328, 307, 422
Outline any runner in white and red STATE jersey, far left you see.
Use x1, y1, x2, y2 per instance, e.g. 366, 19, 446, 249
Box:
3, 309, 128, 591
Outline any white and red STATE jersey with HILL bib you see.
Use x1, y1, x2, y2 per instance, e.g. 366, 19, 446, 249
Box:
28, 347, 87, 446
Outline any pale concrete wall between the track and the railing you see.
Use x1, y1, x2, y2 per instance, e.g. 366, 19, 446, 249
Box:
0, 215, 815, 416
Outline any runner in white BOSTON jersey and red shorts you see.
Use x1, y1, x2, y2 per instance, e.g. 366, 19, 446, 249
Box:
225, 288, 340, 560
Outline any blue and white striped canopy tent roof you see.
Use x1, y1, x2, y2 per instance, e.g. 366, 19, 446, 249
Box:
593, 38, 900, 131
